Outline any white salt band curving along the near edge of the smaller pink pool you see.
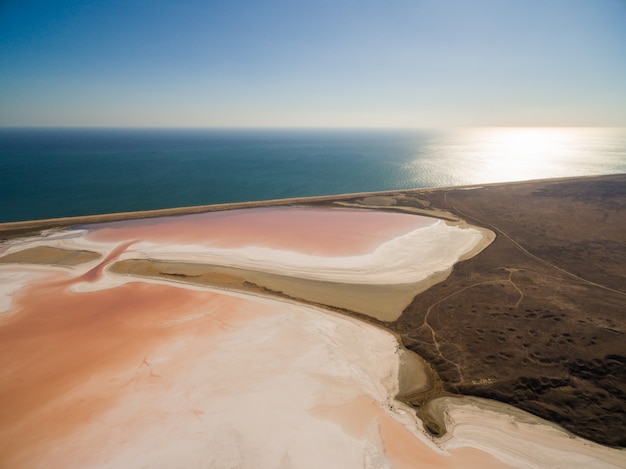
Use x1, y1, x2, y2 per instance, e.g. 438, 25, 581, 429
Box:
114, 221, 483, 284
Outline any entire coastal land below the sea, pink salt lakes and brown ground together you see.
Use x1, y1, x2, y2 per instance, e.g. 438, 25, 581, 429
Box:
0, 176, 626, 467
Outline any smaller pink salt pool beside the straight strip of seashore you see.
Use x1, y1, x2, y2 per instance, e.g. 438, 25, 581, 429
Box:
83, 207, 437, 256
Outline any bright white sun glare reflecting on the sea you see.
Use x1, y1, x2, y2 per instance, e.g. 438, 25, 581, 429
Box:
411, 127, 619, 185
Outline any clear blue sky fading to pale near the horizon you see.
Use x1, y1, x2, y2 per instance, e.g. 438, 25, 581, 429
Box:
0, 0, 626, 127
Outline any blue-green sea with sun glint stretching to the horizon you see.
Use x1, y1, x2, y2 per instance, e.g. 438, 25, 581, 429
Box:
0, 128, 626, 222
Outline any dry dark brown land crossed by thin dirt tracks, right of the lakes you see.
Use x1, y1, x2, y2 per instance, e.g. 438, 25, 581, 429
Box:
368, 175, 626, 446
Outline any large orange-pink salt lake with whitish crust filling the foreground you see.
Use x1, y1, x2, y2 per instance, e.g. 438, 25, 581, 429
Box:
0, 273, 504, 469
